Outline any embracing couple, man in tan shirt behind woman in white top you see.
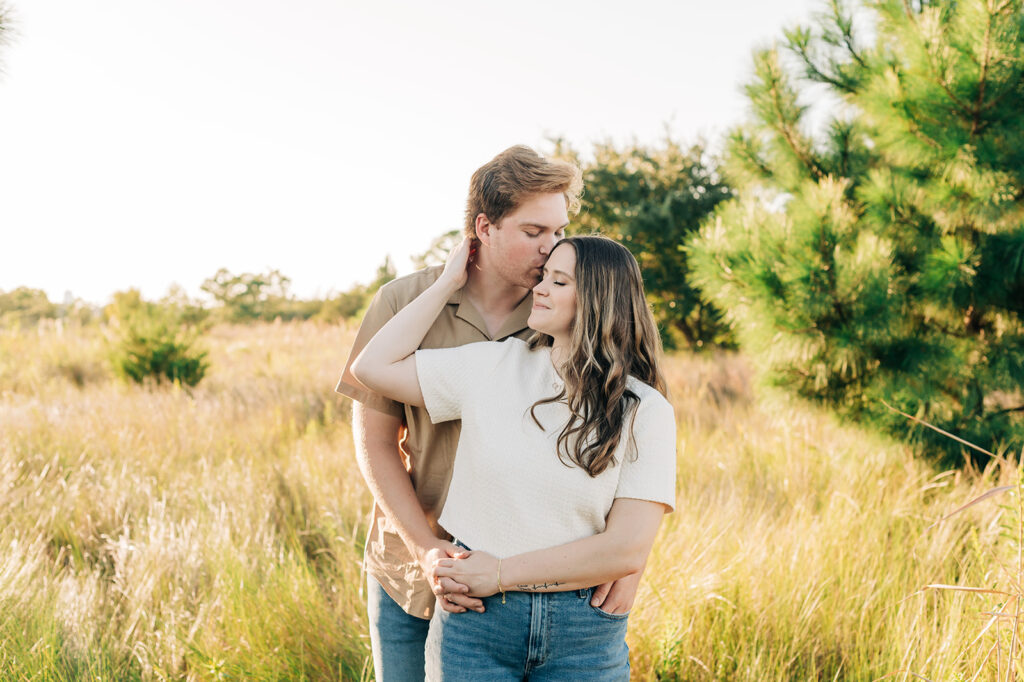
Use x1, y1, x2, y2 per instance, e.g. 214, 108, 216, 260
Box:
337, 146, 676, 682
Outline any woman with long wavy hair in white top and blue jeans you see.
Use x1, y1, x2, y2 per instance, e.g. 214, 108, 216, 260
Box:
352, 237, 676, 680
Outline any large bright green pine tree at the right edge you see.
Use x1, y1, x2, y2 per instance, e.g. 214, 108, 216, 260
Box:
690, 0, 1024, 462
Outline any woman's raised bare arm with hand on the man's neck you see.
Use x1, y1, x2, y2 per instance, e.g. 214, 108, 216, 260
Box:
351, 238, 471, 406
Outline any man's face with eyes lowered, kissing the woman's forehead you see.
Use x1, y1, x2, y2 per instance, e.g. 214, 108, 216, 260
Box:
484, 193, 569, 289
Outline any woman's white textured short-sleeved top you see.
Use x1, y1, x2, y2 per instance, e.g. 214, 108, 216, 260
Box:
416, 338, 676, 557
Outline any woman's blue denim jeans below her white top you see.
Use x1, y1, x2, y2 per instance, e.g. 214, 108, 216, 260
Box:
427, 589, 630, 682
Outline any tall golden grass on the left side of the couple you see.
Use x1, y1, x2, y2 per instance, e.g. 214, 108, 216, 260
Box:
0, 325, 369, 680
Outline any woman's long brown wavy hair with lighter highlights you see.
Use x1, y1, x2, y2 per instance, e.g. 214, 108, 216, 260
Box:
529, 235, 668, 476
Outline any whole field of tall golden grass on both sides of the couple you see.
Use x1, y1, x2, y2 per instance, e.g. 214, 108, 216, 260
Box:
0, 323, 1024, 681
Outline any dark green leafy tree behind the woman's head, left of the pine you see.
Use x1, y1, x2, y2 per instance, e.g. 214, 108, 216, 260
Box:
556, 138, 732, 350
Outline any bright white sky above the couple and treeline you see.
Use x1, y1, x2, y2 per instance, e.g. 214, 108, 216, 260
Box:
0, 0, 820, 303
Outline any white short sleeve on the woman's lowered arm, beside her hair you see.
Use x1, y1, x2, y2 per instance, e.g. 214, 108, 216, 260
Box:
615, 392, 676, 511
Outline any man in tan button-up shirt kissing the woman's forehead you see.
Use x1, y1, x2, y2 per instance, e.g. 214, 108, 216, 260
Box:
337, 146, 639, 682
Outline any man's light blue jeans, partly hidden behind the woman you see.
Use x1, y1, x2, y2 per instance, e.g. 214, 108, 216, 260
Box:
367, 576, 430, 682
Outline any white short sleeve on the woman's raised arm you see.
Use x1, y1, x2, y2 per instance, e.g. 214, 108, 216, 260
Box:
416, 341, 509, 424
